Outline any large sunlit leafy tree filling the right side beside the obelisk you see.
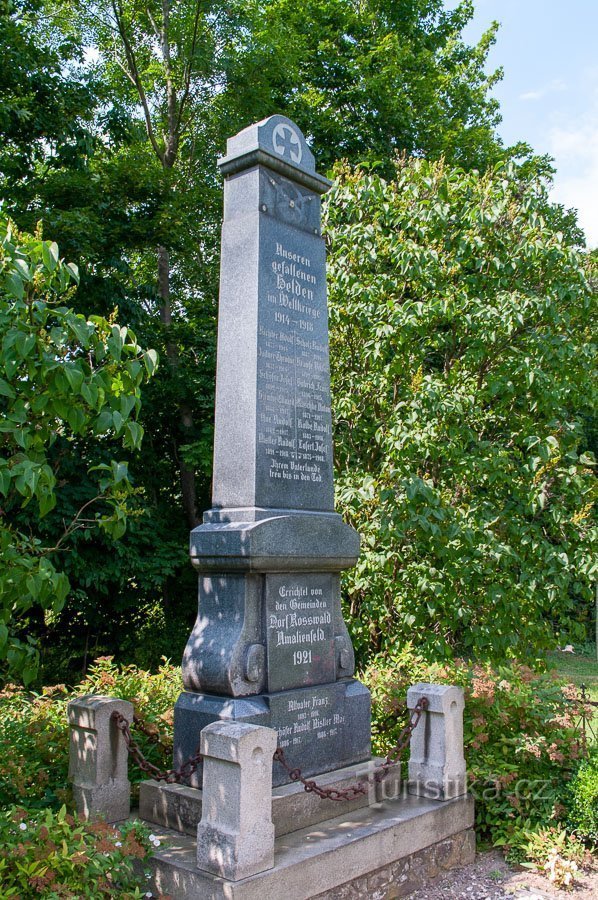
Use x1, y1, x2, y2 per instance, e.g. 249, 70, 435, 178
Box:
326, 160, 598, 660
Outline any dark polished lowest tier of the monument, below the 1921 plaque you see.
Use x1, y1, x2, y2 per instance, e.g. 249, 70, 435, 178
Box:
174, 678, 371, 788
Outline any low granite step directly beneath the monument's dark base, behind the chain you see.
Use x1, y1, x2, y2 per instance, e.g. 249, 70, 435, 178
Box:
139, 759, 407, 837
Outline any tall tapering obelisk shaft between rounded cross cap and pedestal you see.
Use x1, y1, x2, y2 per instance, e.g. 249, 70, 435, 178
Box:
213, 168, 334, 511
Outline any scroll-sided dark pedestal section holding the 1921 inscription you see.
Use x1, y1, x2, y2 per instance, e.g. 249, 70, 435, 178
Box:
182, 558, 355, 697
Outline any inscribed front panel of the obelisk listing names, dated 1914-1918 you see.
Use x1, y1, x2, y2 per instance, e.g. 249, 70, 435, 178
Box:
256, 209, 334, 510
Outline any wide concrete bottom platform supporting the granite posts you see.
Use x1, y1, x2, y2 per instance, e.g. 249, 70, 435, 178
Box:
152, 796, 475, 900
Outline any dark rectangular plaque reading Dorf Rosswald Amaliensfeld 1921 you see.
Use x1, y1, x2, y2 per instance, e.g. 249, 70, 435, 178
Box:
266, 574, 336, 691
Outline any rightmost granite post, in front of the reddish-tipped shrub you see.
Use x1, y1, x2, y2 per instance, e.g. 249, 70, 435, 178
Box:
407, 684, 467, 800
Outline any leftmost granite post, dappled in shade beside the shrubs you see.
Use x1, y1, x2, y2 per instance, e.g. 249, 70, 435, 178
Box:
68, 694, 133, 822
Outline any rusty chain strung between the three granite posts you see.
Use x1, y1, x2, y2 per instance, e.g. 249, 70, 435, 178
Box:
112, 697, 429, 801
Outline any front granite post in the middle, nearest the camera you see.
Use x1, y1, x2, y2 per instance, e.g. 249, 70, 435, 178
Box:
197, 722, 277, 881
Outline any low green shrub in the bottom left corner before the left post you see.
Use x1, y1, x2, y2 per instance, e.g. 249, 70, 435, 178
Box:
0, 806, 155, 900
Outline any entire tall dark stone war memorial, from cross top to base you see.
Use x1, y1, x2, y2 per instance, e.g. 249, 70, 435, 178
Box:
174, 116, 370, 787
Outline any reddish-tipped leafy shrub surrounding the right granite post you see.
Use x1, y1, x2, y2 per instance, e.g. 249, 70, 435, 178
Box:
365, 647, 582, 858
